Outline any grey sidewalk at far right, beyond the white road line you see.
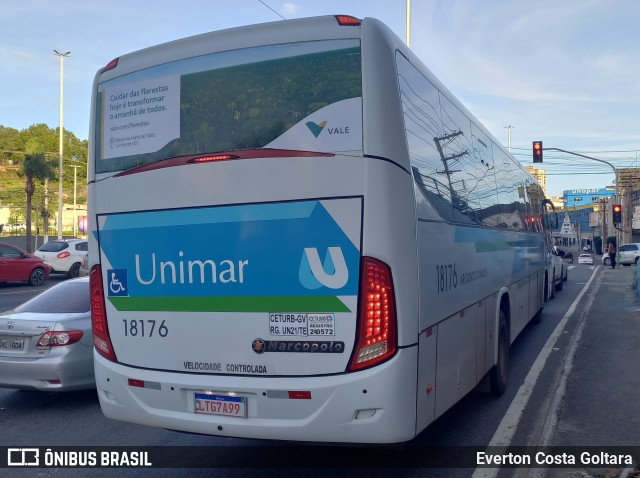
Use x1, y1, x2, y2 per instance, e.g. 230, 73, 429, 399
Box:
547, 266, 640, 478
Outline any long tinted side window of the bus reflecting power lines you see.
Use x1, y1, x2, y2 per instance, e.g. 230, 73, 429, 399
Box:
397, 55, 544, 231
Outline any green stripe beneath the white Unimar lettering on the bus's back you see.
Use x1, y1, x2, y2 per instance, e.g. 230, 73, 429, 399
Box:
109, 296, 351, 312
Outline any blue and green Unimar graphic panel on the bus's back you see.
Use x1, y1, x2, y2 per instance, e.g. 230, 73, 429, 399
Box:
99, 198, 362, 312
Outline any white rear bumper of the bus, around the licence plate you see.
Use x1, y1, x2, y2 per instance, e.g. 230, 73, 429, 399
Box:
94, 347, 418, 443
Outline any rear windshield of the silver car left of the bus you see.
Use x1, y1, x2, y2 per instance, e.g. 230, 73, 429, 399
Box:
14, 280, 90, 314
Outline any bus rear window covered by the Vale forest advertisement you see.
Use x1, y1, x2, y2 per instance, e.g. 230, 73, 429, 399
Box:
95, 40, 362, 173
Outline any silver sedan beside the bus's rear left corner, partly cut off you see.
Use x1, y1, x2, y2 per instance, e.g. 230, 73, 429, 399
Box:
0, 277, 95, 391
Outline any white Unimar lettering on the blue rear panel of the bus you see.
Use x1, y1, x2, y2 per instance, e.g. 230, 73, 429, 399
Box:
135, 251, 249, 285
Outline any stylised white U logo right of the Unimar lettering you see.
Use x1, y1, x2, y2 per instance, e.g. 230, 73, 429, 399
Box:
298, 247, 349, 290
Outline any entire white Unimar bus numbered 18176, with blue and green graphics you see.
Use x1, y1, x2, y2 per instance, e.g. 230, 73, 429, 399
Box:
89, 16, 549, 443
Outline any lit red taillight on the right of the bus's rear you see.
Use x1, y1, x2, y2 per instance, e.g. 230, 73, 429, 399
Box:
349, 257, 397, 371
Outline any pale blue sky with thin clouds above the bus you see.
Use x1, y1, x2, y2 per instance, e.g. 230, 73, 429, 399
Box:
0, 0, 640, 196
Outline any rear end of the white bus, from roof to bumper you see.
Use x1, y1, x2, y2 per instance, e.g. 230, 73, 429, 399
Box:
89, 17, 417, 443
